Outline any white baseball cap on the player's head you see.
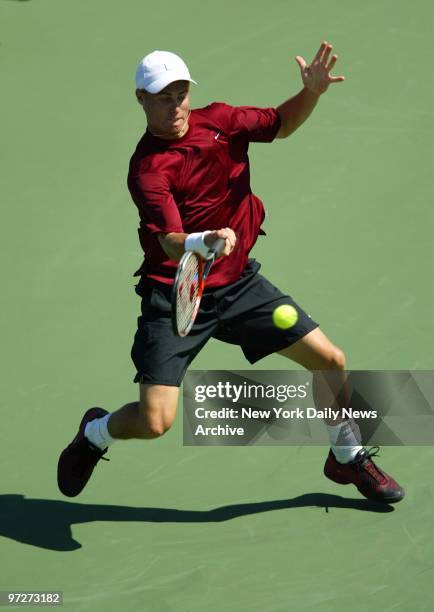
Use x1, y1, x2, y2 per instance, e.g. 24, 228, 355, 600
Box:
136, 51, 197, 93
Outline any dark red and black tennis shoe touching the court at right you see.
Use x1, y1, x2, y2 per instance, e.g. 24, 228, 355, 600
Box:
324, 446, 405, 504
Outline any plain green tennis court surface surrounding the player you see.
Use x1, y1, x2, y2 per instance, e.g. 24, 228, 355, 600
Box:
0, 0, 434, 612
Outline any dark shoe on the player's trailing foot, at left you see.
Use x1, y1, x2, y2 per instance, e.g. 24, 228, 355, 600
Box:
57, 408, 110, 497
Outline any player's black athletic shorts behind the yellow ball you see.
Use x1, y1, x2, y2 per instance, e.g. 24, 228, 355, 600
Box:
131, 259, 318, 387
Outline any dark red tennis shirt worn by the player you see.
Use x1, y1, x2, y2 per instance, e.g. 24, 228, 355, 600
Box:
128, 103, 280, 287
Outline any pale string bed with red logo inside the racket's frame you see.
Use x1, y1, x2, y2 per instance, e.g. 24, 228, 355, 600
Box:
176, 255, 200, 334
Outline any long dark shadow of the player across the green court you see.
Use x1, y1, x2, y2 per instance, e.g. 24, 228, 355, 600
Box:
0, 493, 393, 551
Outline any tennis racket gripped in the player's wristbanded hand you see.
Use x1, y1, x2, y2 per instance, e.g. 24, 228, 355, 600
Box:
172, 238, 226, 337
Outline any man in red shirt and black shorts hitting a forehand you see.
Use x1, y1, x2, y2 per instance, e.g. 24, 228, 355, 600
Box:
58, 42, 404, 502
